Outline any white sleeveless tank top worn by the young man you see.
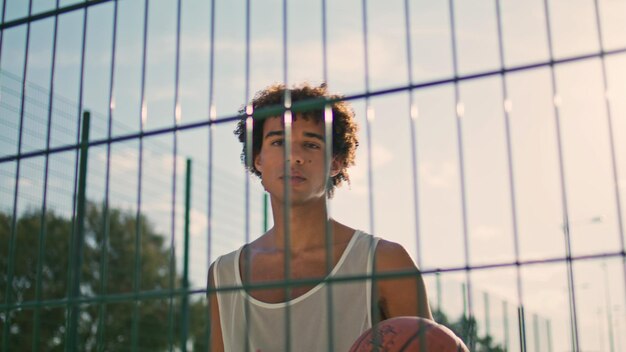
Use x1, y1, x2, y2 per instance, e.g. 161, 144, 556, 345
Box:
214, 230, 379, 352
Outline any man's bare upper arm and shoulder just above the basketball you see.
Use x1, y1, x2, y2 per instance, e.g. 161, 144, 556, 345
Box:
376, 240, 433, 320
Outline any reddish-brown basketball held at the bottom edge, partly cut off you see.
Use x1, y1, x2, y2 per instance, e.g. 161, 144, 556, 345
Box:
350, 317, 469, 352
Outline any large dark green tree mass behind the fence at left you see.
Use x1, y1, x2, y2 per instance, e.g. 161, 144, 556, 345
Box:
0, 203, 206, 351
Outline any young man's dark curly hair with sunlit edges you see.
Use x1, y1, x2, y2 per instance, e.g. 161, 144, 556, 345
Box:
234, 83, 359, 198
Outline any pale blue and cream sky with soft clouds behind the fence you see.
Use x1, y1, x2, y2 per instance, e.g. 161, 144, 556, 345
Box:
0, 0, 626, 351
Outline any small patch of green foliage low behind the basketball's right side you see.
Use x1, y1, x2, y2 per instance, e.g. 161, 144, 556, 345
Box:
433, 310, 505, 352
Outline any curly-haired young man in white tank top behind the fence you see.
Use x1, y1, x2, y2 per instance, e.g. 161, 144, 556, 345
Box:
208, 84, 432, 351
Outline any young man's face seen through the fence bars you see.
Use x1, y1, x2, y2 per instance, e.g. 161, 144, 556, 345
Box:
254, 115, 339, 205
